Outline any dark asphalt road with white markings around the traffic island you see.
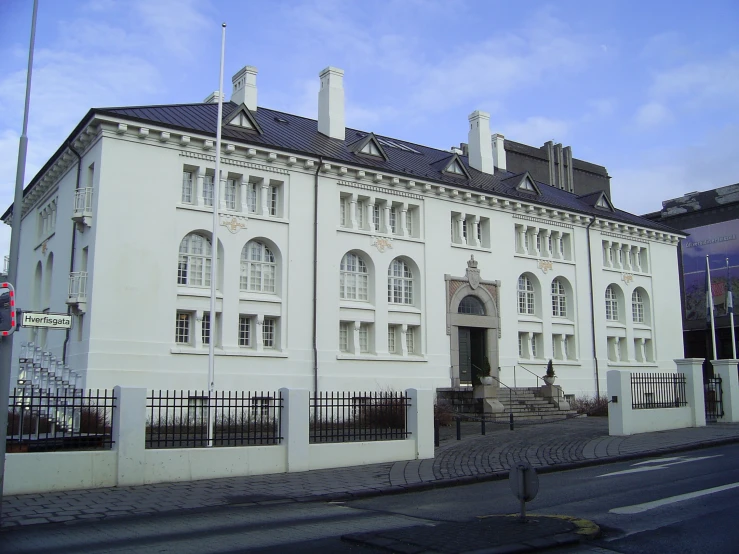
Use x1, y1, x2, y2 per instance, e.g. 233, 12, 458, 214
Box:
0, 445, 739, 554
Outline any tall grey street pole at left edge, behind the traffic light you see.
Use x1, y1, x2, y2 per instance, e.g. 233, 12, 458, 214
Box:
0, 0, 38, 518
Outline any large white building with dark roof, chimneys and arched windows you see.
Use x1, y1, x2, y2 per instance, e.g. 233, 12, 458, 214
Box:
3, 67, 683, 394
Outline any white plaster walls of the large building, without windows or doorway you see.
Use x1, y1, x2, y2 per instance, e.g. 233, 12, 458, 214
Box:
5, 64, 683, 394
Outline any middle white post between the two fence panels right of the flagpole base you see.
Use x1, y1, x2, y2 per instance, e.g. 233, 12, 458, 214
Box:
280, 388, 310, 472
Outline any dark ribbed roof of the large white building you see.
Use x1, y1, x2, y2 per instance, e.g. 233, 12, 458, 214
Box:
3, 102, 679, 233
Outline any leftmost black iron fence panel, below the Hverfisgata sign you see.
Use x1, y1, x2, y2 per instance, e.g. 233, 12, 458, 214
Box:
6, 388, 115, 452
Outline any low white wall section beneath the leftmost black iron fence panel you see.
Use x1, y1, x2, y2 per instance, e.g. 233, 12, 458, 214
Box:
3, 450, 118, 494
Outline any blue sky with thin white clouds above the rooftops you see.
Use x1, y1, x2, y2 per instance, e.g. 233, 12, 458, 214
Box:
0, 0, 739, 253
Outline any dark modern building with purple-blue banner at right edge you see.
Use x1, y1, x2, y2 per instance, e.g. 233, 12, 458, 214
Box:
644, 183, 739, 359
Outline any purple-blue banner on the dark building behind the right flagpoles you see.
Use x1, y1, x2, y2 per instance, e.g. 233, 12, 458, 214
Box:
681, 220, 739, 320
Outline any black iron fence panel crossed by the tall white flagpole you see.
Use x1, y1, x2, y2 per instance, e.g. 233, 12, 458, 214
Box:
146, 390, 283, 448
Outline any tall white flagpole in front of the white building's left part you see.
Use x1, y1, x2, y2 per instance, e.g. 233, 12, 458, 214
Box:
208, 23, 226, 446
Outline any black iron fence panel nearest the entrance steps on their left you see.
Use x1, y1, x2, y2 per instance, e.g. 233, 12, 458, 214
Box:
310, 392, 410, 443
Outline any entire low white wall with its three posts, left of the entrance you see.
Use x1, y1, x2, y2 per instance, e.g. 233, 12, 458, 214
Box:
5, 387, 434, 494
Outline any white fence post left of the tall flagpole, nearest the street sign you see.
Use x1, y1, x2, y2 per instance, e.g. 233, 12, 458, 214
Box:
113, 387, 146, 486
